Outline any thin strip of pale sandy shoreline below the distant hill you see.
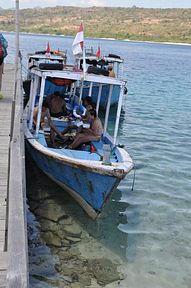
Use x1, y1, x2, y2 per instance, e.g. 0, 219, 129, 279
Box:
2, 31, 191, 46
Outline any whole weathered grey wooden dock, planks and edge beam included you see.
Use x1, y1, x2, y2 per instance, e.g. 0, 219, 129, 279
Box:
0, 64, 29, 288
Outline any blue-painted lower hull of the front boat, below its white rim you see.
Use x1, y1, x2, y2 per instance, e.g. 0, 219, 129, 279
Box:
26, 141, 121, 214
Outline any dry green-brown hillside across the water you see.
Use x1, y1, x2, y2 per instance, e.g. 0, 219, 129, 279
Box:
0, 6, 191, 43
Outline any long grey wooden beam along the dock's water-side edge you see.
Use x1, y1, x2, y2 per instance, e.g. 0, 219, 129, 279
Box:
7, 55, 29, 288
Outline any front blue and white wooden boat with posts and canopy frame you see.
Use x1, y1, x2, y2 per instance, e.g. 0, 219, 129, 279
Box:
25, 67, 133, 219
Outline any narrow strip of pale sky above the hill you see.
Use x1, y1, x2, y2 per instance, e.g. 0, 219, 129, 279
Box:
0, 0, 191, 9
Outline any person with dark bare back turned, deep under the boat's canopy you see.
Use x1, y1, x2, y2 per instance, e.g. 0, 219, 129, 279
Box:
47, 91, 67, 118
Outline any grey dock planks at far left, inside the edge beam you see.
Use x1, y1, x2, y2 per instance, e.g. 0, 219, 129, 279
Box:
0, 65, 14, 287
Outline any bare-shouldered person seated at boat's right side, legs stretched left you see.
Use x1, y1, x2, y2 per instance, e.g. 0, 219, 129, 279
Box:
68, 109, 103, 149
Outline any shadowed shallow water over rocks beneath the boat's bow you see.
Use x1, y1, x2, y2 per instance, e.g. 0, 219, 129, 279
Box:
26, 155, 131, 288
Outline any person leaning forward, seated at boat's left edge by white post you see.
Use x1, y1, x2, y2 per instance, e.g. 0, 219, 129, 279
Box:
33, 100, 62, 146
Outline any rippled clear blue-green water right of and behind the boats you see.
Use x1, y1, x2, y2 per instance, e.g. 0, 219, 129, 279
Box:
6, 34, 191, 288
